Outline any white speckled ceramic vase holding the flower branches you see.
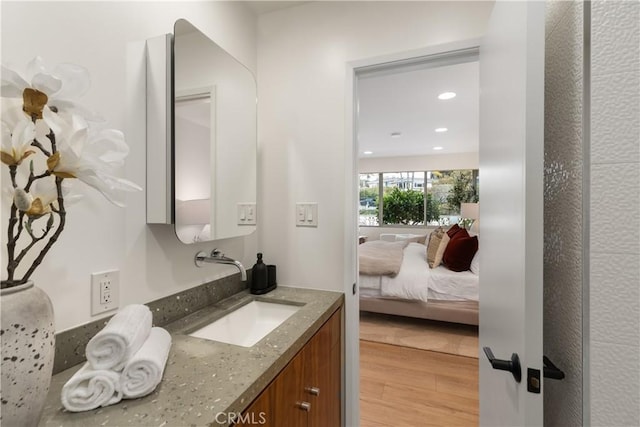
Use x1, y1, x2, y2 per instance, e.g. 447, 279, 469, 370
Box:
0, 281, 55, 426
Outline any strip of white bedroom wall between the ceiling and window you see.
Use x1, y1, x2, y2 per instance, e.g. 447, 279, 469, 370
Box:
358, 152, 479, 173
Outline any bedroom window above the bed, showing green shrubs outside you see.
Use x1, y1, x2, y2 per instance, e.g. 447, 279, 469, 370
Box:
359, 169, 479, 226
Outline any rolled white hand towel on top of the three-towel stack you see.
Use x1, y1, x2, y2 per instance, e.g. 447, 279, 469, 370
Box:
85, 304, 153, 371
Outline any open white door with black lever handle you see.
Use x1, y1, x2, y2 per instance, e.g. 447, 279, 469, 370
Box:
479, 1, 545, 426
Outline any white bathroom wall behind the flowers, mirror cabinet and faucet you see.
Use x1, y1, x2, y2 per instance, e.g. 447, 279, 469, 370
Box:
2, 1, 257, 331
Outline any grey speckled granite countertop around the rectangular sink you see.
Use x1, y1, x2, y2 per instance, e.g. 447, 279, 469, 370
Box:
40, 286, 344, 427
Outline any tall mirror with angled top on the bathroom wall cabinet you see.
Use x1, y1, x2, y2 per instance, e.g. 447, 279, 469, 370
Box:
173, 19, 257, 243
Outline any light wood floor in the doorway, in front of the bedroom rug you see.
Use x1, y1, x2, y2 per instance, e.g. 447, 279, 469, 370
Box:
360, 340, 479, 427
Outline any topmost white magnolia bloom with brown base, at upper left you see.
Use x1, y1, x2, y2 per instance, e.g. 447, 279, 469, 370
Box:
1, 56, 102, 120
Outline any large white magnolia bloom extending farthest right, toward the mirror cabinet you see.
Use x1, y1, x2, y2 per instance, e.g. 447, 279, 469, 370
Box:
43, 109, 142, 206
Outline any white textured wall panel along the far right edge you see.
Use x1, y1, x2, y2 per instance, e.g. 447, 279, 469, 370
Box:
588, 0, 640, 426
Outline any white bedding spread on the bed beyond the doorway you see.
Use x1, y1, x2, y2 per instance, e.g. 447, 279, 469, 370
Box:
359, 243, 478, 301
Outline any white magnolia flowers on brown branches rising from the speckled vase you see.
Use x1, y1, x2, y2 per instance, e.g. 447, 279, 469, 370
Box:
0, 57, 141, 289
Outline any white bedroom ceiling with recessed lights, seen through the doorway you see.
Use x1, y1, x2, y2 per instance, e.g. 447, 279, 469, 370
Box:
358, 61, 479, 158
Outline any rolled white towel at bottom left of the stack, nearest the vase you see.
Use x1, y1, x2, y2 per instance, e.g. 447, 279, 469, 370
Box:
60, 363, 122, 412
